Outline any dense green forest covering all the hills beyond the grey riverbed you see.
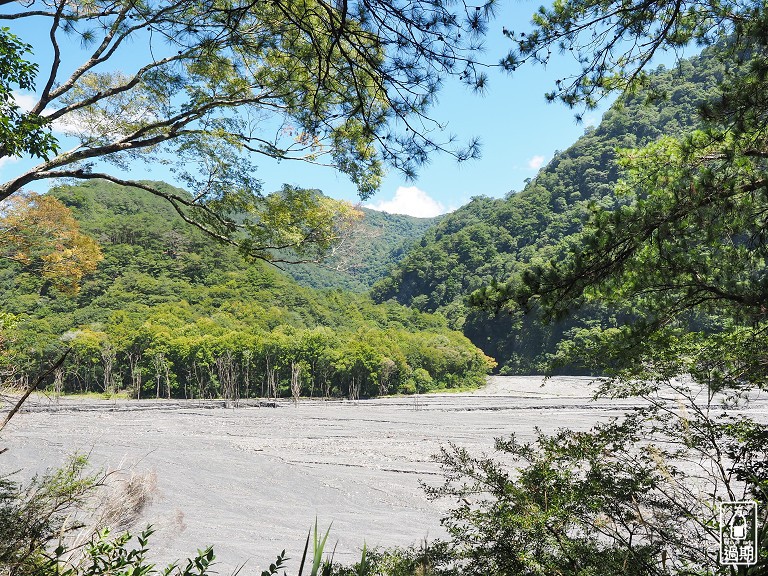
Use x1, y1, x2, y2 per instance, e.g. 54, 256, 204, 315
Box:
0, 46, 722, 397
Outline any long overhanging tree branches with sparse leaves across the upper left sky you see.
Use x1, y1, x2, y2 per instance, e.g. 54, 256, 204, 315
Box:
0, 0, 494, 258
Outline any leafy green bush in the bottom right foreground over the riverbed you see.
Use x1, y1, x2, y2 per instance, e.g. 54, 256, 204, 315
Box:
428, 383, 768, 576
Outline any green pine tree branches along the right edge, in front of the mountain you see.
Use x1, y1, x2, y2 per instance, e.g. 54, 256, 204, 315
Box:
473, 7, 768, 387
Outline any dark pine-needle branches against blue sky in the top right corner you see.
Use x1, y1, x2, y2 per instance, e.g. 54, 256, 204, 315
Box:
501, 0, 766, 111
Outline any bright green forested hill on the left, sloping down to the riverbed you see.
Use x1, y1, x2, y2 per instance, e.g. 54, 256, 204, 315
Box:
0, 180, 492, 397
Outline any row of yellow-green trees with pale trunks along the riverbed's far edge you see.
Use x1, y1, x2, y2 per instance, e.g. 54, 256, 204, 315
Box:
30, 318, 492, 399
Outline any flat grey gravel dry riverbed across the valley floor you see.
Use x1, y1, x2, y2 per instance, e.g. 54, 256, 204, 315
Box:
0, 377, 766, 574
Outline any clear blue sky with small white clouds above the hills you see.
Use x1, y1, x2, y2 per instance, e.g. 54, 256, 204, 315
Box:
0, 0, 684, 216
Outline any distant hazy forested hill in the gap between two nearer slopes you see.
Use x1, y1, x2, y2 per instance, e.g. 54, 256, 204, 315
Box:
278, 208, 440, 292
